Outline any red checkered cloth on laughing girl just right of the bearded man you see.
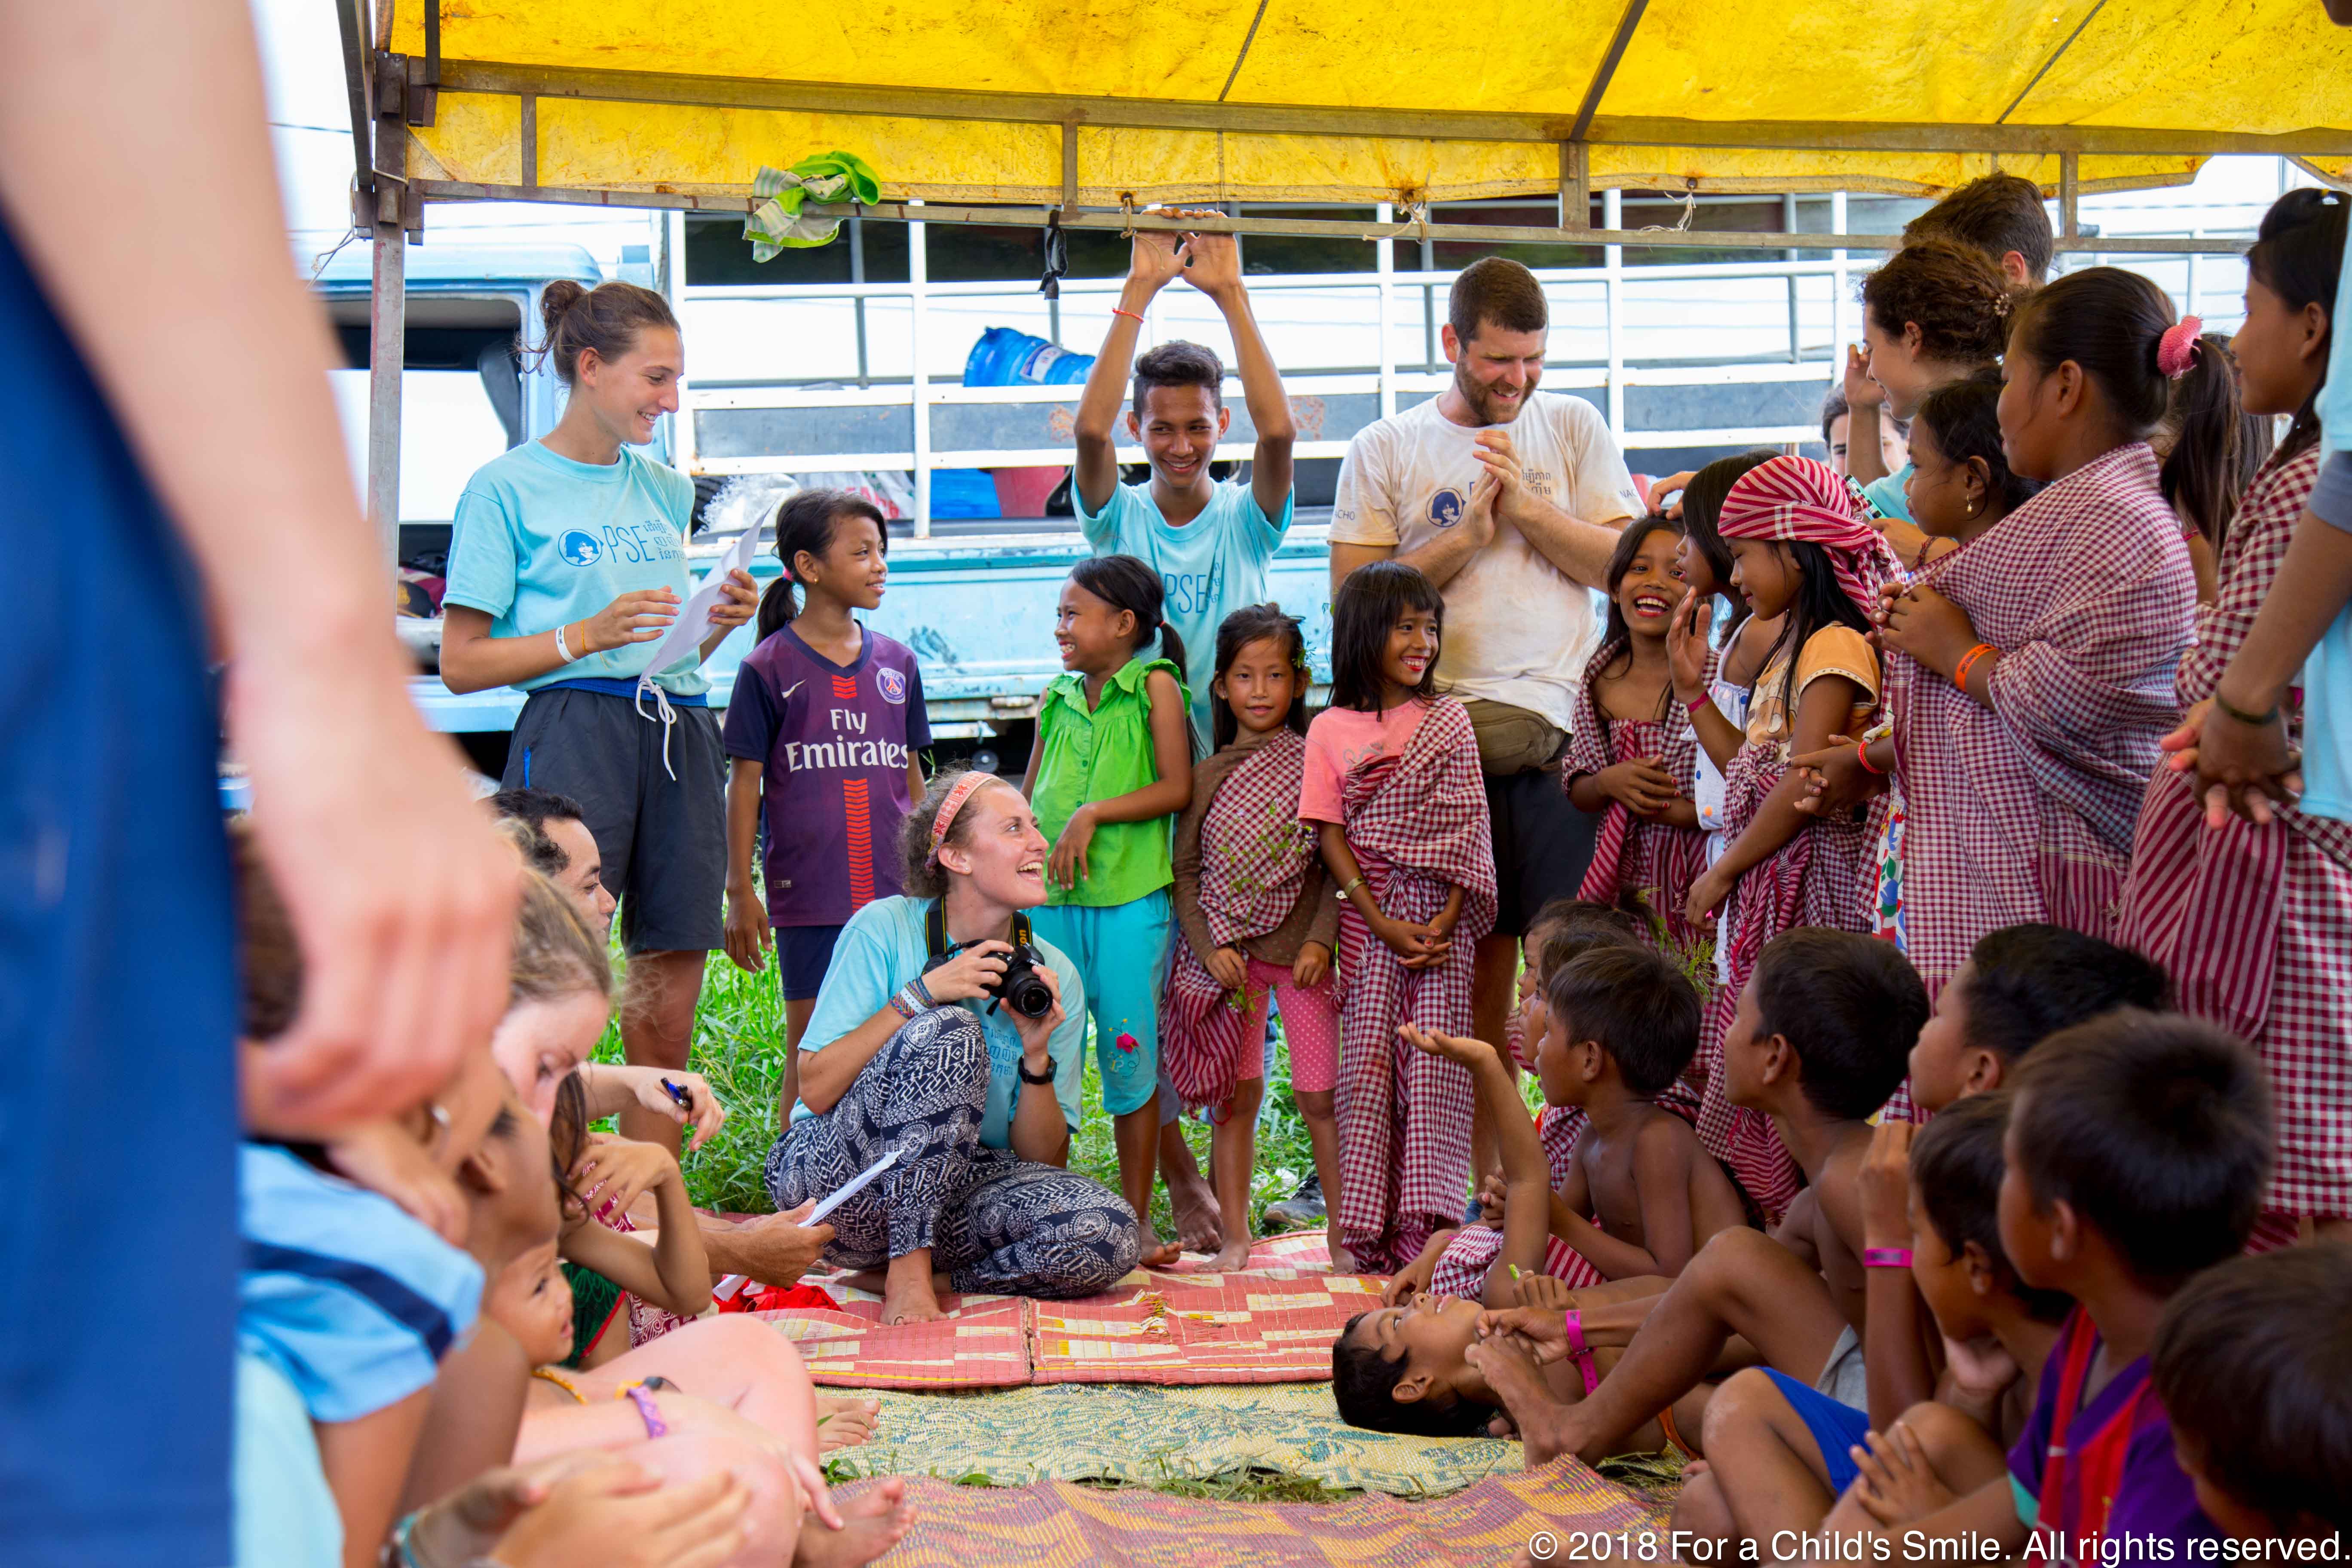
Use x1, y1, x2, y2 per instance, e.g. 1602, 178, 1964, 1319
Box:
1559, 642, 1722, 947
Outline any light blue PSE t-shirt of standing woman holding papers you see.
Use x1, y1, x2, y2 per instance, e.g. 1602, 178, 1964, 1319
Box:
447, 442, 710, 696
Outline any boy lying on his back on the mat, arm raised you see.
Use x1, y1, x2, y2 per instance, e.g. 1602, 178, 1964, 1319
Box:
1331, 1025, 1700, 1448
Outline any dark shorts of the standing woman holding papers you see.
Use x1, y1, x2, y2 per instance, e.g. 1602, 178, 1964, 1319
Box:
501, 689, 727, 952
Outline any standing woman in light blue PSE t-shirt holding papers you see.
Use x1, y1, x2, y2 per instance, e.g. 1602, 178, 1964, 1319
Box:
442, 280, 757, 1140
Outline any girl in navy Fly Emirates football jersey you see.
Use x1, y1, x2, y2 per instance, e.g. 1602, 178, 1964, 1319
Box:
724, 489, 931, 1107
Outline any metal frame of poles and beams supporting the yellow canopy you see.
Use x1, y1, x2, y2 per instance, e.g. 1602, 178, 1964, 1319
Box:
336, 0, 2352, 560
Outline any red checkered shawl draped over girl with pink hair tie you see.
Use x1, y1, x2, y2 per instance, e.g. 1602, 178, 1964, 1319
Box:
1886, 442, 2197, 994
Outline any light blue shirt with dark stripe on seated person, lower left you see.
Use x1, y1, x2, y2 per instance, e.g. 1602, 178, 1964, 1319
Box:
238, 1142, 482, 1422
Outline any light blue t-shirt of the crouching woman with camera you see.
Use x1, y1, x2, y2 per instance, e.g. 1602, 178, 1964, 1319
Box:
793, 898, 1087, 1149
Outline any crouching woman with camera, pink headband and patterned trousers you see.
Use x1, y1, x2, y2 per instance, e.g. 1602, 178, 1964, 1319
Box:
767, 771, 1141, 1323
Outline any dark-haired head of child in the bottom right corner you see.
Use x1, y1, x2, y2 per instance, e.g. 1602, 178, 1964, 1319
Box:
2150, 1246, 2352, 1561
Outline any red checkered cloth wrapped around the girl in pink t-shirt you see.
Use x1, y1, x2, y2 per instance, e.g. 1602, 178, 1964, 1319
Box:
1336, 698, 1496, 1272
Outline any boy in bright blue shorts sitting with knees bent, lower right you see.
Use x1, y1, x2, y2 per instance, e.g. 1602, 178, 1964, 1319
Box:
1675, 1093, 2074, 1552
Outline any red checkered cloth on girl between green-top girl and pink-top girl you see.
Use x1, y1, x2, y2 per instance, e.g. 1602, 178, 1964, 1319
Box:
1160, 729, 1315, 1105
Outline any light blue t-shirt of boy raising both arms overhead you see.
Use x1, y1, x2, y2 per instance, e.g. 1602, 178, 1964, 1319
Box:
1070, 480, 1298, 745
